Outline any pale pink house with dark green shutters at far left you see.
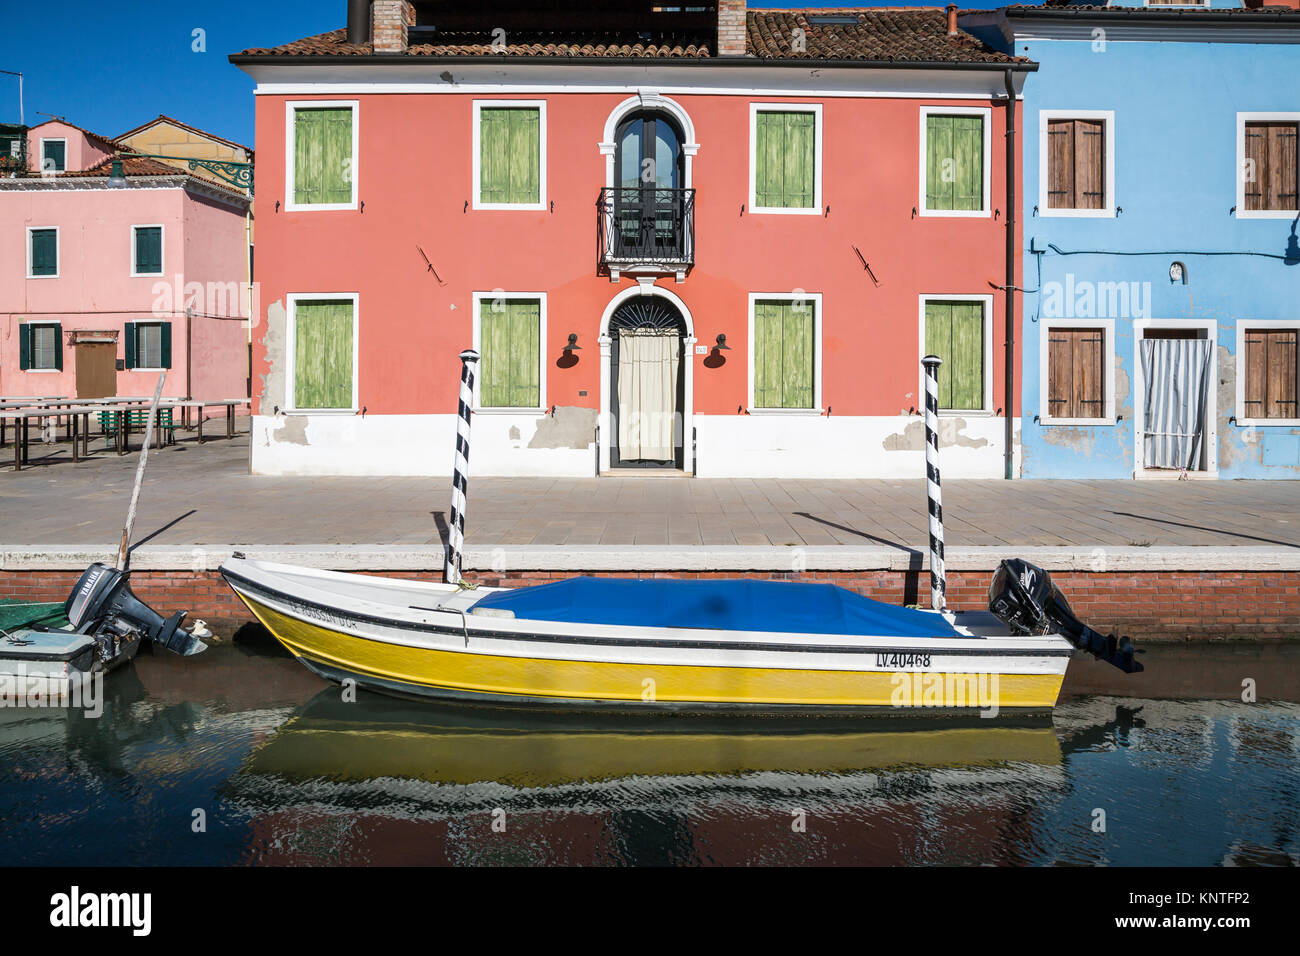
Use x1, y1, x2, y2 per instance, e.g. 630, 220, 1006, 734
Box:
0, 121, 251, 399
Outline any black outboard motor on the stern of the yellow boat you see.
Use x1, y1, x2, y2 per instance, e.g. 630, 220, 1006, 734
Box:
988, 558, 1143, 674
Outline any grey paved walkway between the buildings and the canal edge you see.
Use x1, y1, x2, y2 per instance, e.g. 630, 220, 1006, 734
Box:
0, 429, 1300, 550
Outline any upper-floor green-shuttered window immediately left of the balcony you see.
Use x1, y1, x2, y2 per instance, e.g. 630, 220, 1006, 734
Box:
473, 100, 546, 211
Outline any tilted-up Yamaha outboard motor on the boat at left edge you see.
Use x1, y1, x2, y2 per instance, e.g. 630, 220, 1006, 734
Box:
64, 563, 208, 659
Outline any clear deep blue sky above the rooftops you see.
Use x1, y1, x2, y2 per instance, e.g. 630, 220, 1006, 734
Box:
0, 0, 998, 146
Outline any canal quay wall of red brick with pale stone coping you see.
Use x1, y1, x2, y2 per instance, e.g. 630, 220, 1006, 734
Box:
0, 544, 1300, 641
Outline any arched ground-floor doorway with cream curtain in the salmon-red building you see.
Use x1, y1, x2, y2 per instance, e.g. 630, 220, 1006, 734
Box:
602, 290, 694, 470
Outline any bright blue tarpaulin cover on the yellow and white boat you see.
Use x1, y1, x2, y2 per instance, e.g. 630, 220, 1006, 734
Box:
475, 578, 959, 637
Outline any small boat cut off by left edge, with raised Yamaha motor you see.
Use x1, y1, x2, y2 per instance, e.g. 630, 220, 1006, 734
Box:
0, 563, 207, 706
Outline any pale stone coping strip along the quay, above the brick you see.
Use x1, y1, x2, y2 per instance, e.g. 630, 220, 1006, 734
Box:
0, 544, 1300, 574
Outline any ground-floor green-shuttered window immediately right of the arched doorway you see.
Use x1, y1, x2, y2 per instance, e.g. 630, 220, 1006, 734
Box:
749, 293, 822, 415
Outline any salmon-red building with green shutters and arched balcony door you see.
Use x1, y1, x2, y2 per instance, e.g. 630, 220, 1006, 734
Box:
231, 0, 1035, 477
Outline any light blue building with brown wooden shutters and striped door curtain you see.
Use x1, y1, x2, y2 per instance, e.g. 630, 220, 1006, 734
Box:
961, 0, 1300, 479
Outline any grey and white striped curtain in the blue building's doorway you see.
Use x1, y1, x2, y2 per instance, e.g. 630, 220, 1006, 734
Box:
1141, 338, 1213, 471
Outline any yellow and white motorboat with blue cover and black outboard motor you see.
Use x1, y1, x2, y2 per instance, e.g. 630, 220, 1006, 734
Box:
221, 554, 1141, 713
